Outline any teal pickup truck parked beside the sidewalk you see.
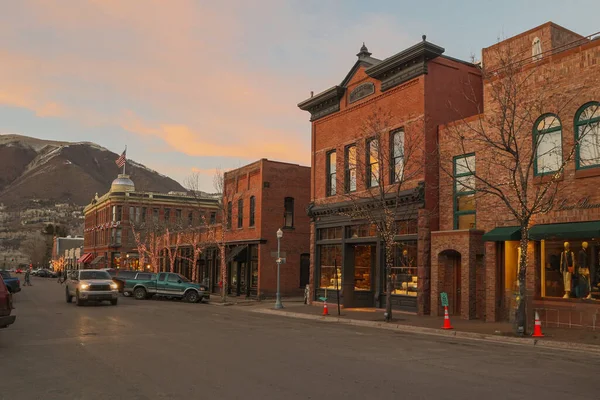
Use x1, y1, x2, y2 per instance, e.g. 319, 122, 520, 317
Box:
123, 272, 210, 303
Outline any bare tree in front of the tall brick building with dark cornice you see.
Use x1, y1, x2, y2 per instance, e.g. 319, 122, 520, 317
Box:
328, 108, 425, 322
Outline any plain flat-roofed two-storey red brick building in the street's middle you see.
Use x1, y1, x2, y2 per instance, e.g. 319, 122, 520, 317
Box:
210, 159, 310, 298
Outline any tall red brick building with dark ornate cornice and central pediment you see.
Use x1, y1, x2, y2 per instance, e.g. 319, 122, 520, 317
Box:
298, 36, 481, 314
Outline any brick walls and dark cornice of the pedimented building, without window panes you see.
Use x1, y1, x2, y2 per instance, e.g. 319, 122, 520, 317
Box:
299, 37, 481, 314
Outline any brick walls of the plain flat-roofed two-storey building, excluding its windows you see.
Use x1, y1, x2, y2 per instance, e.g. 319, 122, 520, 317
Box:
223, 159, 310, 298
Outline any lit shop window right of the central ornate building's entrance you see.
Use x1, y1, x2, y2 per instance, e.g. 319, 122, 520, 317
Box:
391, 241, 417, 296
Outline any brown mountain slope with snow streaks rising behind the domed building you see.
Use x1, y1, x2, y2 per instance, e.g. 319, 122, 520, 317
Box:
0, 135, 185, 208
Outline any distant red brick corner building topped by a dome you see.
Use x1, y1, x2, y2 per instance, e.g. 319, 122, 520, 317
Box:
79, 175, 219, 269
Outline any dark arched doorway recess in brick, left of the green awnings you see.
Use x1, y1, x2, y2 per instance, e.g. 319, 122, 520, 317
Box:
437, 249, 463, 315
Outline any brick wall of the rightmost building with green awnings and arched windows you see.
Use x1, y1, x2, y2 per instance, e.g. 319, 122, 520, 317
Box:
431, 23, 600, 321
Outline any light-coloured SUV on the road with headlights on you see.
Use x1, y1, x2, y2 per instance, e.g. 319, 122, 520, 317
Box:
65, 269, 119, 306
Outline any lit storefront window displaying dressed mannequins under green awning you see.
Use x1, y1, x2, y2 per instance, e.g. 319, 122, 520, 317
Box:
542, 239, 600, 299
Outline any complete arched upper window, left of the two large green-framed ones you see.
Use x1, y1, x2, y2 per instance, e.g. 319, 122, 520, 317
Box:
533, 114, 563, 175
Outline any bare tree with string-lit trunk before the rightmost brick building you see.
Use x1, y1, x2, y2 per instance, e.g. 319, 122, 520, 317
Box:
439, 38, 591, 334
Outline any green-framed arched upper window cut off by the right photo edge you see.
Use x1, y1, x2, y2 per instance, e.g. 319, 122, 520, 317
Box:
575, 101, 600, 169
